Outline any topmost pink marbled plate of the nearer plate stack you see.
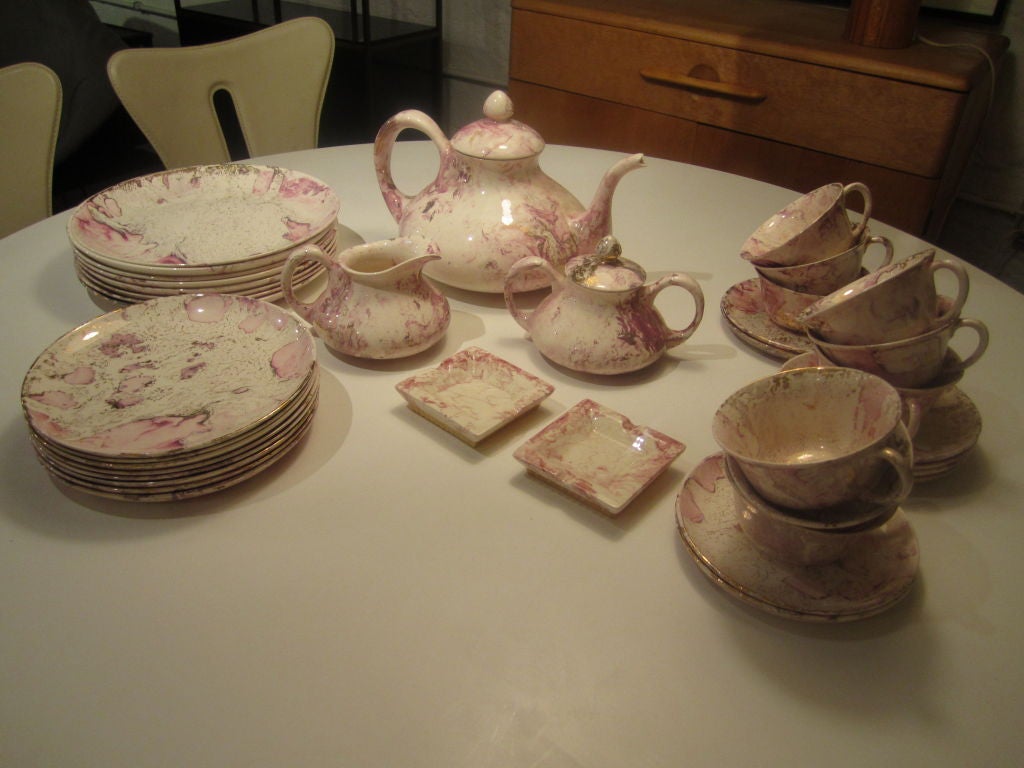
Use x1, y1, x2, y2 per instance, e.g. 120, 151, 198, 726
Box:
22, 294, 316, 457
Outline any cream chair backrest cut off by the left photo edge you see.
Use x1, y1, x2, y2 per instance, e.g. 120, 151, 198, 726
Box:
0, 61, 60, 238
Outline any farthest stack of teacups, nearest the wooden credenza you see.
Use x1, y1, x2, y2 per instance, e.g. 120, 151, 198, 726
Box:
740, 182, 893, 334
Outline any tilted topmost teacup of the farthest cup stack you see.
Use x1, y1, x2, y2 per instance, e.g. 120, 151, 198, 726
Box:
739, 181, 871, 266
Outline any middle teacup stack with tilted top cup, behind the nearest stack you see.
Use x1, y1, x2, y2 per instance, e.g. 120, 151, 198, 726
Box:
797, 249, 988, 479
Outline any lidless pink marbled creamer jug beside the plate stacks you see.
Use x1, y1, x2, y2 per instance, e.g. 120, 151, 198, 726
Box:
281, 240, 452, 359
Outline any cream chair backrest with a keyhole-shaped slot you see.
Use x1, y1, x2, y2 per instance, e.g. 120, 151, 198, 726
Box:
106, 16, 335, 168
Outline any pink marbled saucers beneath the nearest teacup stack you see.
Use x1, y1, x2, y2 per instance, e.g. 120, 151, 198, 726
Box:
676, 454, 919, 622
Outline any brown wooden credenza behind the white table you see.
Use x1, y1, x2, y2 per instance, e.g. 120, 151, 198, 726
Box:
509, 0, 1009, 240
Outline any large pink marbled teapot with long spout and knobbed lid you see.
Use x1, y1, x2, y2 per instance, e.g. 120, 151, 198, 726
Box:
374, 91, 644, 293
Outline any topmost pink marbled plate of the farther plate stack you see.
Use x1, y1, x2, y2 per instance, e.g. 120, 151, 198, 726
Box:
68, 165, 340, 274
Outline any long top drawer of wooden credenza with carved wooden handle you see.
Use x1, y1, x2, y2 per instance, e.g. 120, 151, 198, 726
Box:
511, 9, 966, 177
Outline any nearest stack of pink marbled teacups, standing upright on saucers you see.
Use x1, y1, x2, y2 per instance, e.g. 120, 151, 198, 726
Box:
712, 367, 913, 565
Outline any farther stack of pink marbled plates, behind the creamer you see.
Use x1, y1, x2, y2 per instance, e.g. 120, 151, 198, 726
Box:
68, 165, 340, 304
